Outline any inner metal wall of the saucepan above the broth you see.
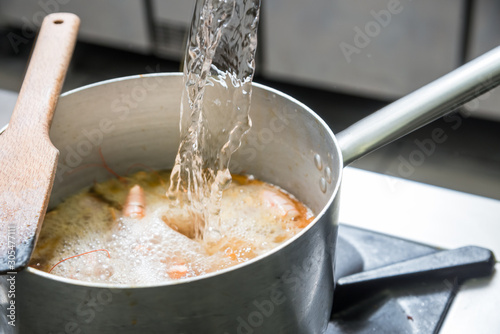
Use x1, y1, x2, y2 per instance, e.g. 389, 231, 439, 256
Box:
49, 73, 342, 214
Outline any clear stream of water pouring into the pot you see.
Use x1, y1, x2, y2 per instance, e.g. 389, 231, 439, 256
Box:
169, 0, 260, 241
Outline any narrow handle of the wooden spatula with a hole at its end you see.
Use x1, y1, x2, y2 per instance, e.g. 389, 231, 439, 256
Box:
8, 13, 80, 134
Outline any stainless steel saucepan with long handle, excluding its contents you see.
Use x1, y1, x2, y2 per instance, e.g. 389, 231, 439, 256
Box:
2, 48, 500, 334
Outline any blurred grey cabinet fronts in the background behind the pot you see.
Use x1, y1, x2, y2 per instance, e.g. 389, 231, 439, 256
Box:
0, 0, 500, 120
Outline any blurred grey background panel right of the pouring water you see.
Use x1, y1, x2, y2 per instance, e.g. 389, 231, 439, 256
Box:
260, 0, 464, 98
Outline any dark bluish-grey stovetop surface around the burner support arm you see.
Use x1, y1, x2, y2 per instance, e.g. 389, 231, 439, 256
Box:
325, 224, 458, 334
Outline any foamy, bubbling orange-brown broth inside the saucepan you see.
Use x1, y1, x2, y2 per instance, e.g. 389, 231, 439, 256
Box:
30, 171, 313, 285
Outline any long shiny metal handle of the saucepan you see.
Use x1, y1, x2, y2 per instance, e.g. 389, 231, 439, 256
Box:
336, 47, 500, 165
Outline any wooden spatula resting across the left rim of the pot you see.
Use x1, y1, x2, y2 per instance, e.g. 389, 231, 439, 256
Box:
0, 13, 80, 273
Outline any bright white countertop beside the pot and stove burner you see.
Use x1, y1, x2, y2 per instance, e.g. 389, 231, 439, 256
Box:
0, 90, 500, 334
